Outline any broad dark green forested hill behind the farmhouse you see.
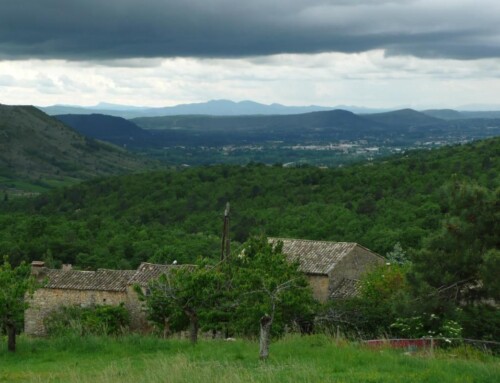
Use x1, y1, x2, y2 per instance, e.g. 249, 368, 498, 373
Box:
0, 138, 500, 267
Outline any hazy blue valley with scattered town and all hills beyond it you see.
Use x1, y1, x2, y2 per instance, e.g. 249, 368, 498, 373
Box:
40, 100, 500, 167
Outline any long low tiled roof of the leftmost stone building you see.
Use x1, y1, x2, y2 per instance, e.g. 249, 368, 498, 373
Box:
44, 269, 136, 291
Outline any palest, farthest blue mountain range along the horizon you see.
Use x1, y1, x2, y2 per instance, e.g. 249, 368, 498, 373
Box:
38, 100, 500, 120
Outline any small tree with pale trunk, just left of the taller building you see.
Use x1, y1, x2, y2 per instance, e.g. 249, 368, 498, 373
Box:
226, 237, 317, 360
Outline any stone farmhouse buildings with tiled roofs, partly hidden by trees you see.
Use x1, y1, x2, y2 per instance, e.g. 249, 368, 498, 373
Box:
24, 238, 384, 335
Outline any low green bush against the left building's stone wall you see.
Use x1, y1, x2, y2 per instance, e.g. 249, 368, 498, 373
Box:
44, 303, 130, 336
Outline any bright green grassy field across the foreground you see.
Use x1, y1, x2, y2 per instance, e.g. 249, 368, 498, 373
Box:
0, 335, 500, 383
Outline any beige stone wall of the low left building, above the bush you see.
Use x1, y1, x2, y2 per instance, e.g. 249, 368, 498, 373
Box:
24, 288, 127, 336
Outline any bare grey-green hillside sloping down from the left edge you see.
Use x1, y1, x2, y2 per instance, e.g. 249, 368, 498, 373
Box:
0, 105, 154, 191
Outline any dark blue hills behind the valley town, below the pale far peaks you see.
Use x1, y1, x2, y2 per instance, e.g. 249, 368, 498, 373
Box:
52, 109, 500, 149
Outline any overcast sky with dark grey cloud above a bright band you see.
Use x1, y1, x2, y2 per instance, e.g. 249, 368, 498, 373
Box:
0, 0, 500, 108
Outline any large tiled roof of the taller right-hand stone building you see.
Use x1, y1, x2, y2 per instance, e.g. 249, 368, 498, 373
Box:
269, 238, 358, 275
